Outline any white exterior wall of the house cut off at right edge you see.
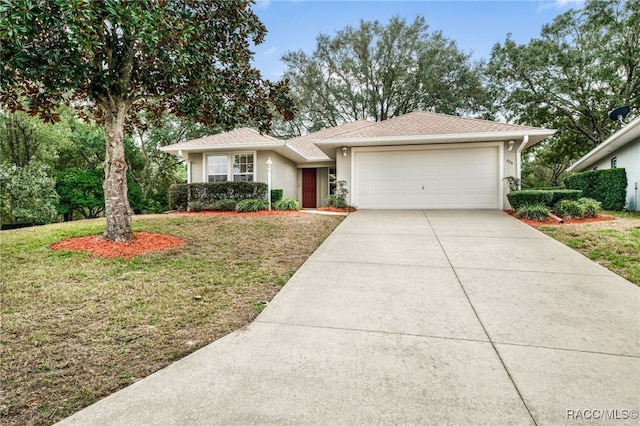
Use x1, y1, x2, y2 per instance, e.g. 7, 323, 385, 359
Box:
583, 139, 640, 211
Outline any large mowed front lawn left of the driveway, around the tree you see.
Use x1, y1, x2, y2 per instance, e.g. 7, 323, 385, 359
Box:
0, 213, 343, 425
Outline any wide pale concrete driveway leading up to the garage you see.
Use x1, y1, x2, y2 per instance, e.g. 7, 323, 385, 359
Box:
57, 210, 640, 425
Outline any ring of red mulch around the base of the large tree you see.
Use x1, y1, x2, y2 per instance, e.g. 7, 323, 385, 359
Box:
51, 232, 186, 259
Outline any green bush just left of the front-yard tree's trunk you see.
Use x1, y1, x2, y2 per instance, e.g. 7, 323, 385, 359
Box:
55, 167, 104, 221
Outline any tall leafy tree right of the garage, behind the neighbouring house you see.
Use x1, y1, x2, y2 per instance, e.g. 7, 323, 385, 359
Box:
487, 0, 640, 185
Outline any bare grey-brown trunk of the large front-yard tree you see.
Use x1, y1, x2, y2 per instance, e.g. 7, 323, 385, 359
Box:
102, 101, 133, 242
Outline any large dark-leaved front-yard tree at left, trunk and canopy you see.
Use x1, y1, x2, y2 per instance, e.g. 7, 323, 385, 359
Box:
0, 0, 293, 241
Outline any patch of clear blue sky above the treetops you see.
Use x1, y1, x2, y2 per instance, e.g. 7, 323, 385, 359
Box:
253, 0, 583, 80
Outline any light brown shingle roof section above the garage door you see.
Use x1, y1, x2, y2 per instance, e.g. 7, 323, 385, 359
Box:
316, 111, 540, 140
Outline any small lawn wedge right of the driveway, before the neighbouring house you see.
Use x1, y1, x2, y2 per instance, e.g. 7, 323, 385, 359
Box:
538, 212, 640, 286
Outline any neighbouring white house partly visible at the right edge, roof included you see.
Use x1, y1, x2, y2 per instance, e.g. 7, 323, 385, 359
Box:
567, 117, 640, 211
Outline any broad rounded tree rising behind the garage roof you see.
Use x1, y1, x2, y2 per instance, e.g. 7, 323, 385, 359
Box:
282, 16, 486, 135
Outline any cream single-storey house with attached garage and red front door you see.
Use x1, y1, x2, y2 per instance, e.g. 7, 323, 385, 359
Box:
161, 111, 555, 209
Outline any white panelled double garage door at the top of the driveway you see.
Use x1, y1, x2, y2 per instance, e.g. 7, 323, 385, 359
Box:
352, 146, 499, 209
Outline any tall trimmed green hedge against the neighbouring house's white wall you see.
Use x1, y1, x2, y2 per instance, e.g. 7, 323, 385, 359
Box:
564, 169, 627, 210
